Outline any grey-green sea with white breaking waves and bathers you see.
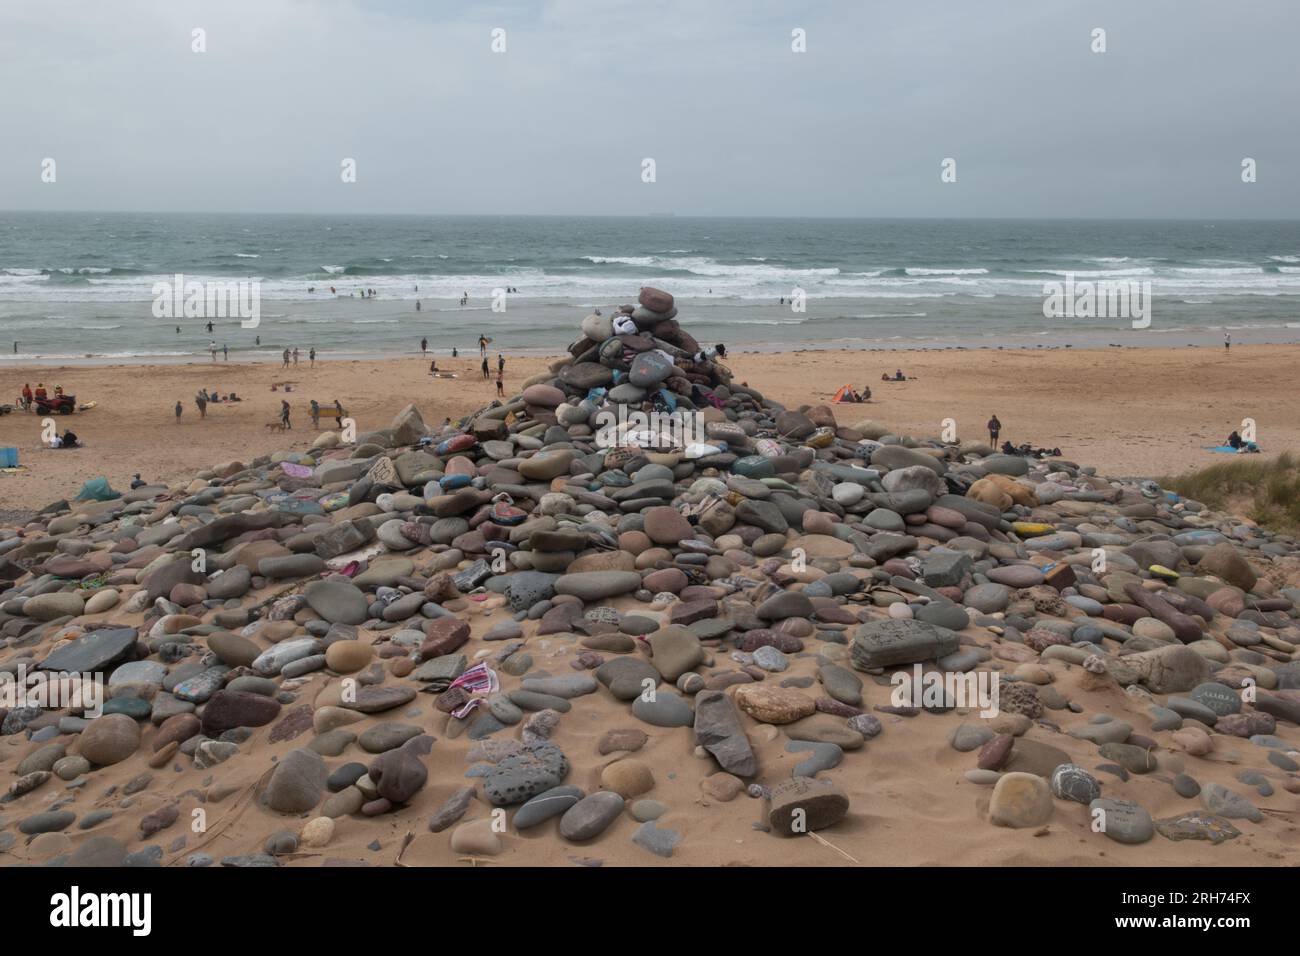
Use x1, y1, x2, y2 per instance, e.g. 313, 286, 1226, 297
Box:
0, 212, 1300, 367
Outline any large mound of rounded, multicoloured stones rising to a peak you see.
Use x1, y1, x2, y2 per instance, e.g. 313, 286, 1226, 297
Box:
0, 289, 1300, 865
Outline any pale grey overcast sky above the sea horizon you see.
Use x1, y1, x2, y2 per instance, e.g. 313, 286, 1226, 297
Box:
0, 0, 1300, 219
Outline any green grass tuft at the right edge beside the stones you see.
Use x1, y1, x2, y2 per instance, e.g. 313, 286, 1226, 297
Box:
1160, 453, 1300, 533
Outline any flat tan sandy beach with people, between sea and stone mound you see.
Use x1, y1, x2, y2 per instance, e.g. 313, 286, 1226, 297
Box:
0, 345, 1300, 511
